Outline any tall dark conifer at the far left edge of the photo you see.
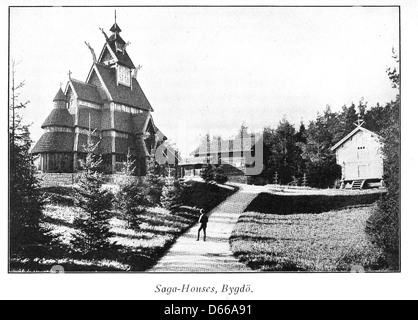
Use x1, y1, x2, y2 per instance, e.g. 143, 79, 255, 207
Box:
9, 62, 55, 259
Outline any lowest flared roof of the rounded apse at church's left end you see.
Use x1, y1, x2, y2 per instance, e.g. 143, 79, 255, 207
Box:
31, 132, 74, 154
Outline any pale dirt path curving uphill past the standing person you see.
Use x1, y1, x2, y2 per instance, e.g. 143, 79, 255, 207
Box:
149, 185, 263, 272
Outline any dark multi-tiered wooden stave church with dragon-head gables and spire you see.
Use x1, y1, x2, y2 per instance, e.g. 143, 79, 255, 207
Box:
31, 19, 167, 175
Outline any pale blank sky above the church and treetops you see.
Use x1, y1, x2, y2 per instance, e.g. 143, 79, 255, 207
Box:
10, 7, 399, 157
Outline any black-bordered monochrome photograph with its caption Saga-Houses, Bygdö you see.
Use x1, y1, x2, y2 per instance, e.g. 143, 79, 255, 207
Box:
3, 3, 418, 296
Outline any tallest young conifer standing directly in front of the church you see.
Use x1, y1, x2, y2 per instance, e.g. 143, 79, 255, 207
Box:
71, 131, 116, 258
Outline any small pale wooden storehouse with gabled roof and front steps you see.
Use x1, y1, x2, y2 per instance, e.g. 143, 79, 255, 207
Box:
331, 120, 383, 189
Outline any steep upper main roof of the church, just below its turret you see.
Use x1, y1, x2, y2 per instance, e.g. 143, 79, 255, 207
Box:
94, 63, 153, 111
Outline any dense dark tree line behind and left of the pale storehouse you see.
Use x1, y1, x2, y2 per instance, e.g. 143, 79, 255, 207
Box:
255, 100, 393, 188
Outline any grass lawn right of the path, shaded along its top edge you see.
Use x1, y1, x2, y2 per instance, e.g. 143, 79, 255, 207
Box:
230, 193, 384, 271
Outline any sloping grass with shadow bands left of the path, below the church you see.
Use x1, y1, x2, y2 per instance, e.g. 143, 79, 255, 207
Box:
11, 183, 236, 272
